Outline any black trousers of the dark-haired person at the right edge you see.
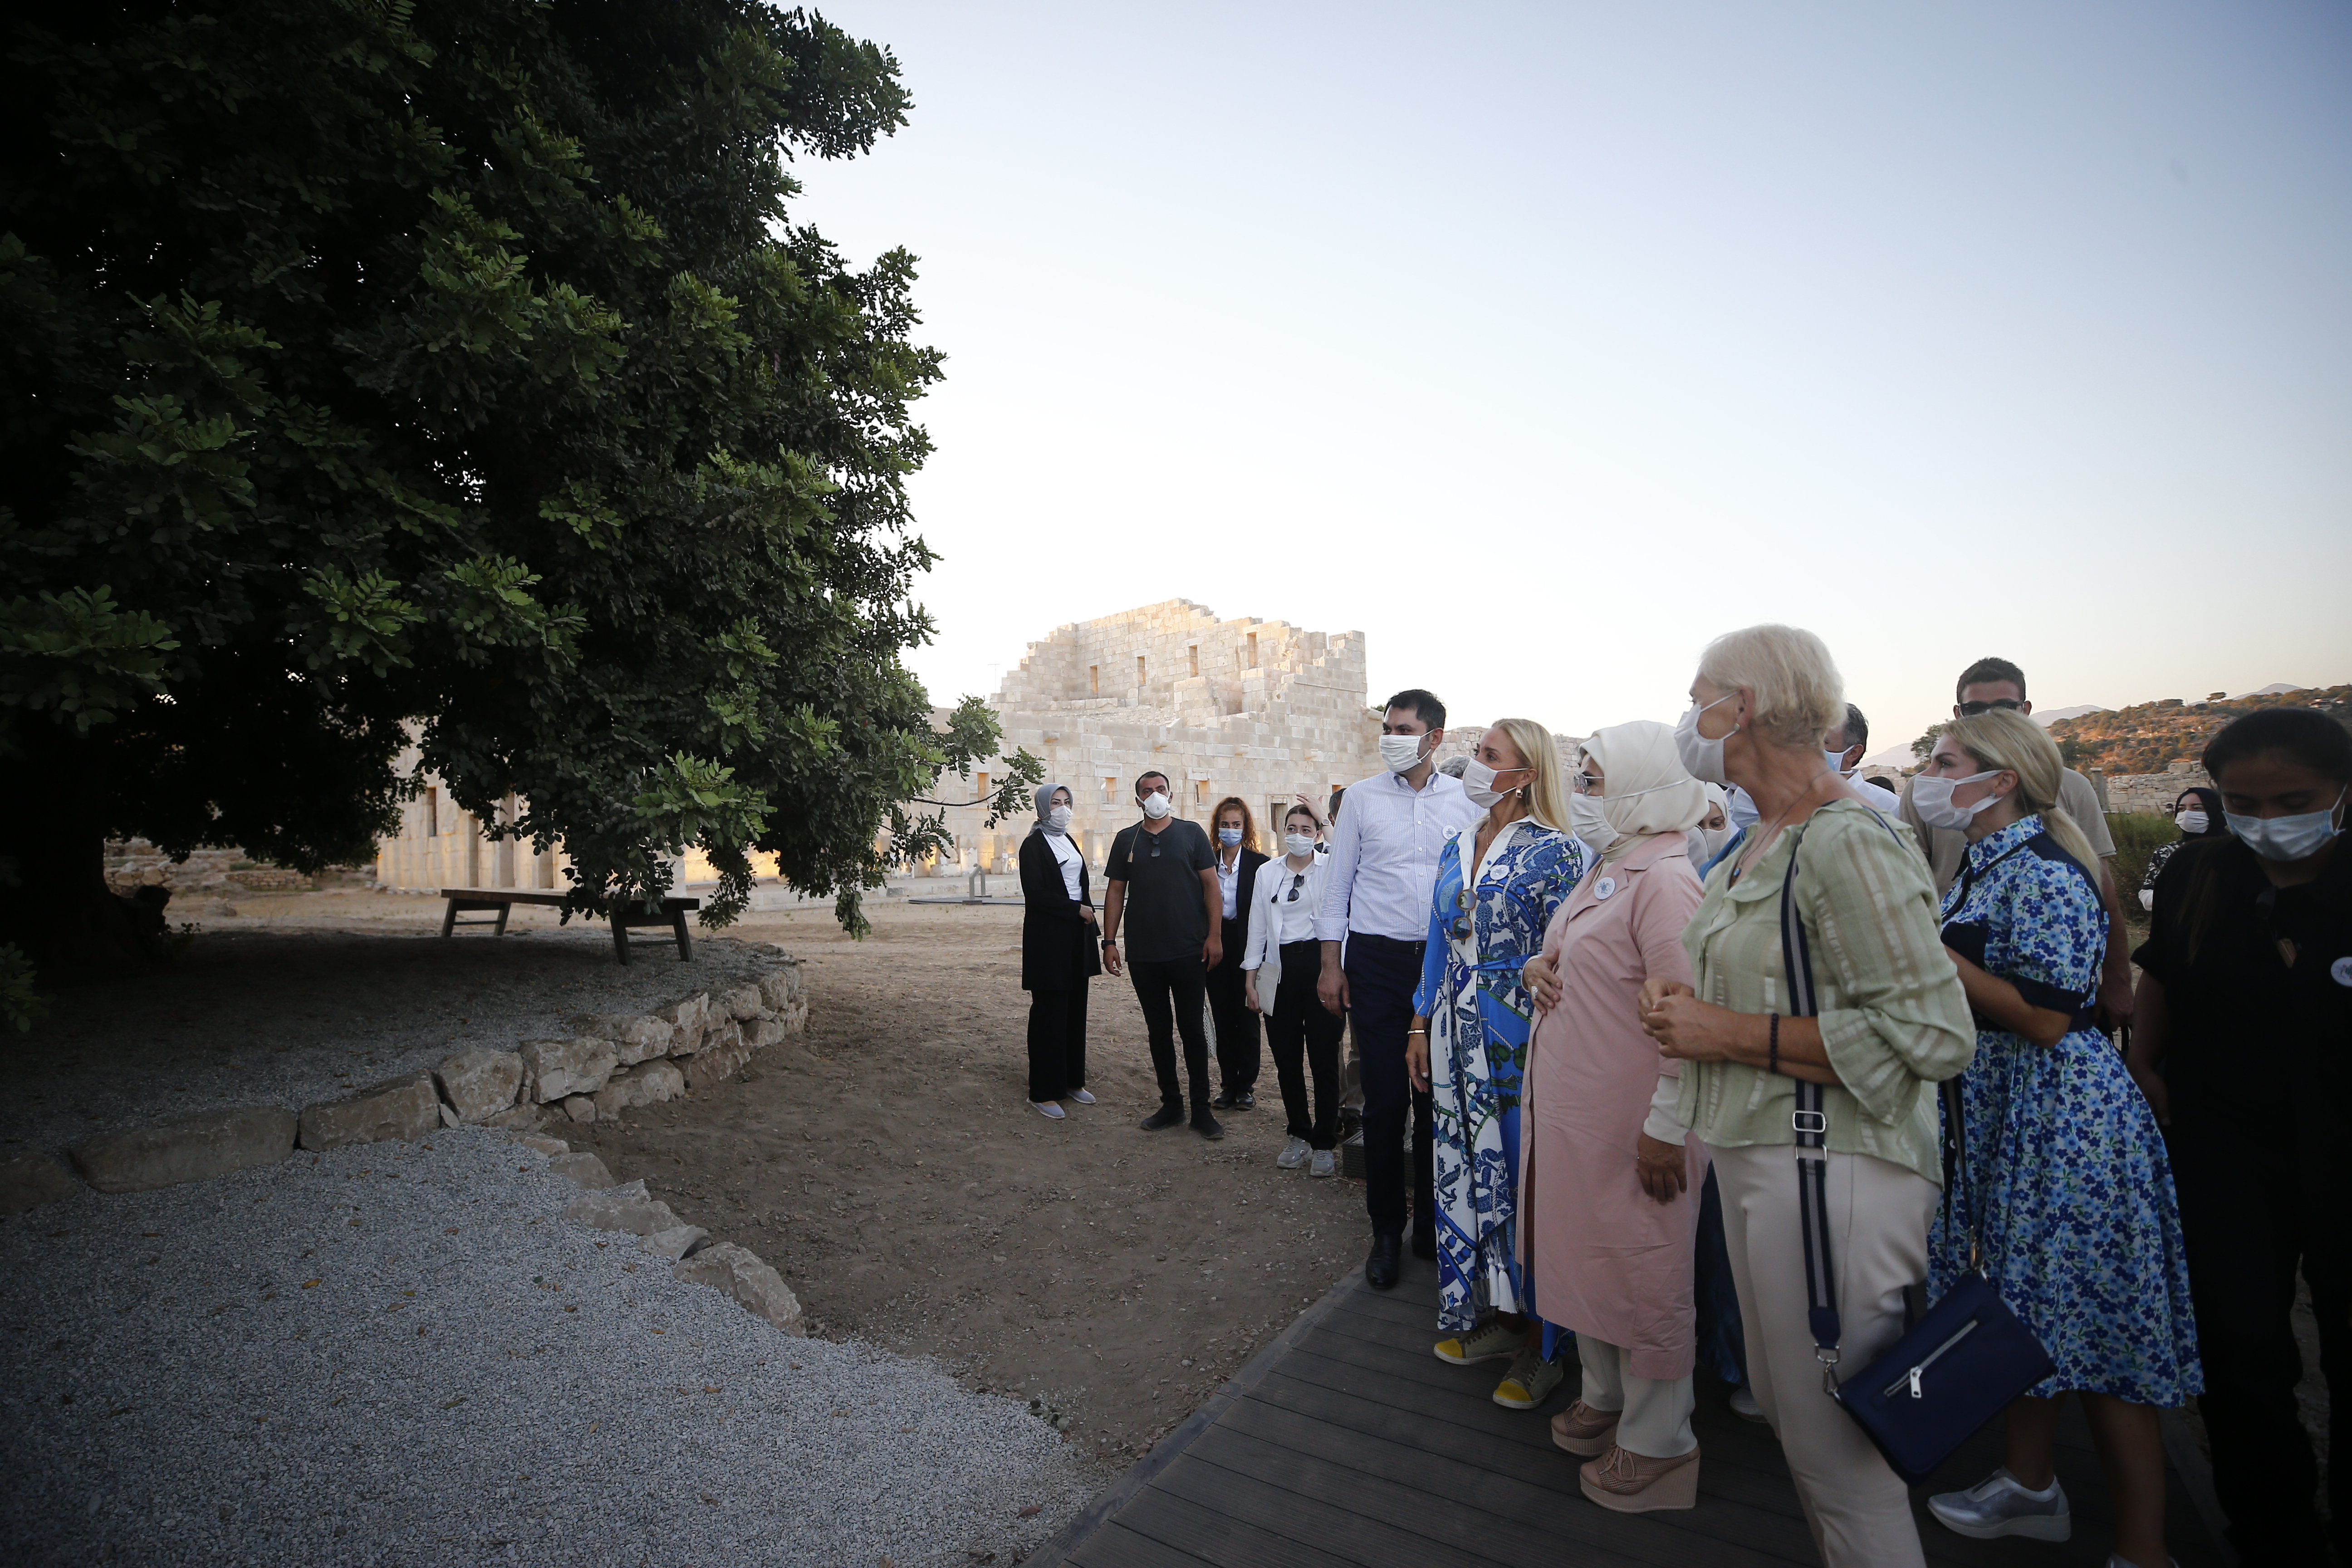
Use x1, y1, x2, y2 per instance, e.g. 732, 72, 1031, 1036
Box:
2166, 1128, 2352, 1568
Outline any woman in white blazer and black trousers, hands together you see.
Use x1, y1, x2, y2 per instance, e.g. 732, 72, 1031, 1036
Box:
1242, 804, 1348, 1176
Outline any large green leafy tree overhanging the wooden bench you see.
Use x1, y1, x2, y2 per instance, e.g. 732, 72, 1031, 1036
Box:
0, 0, 1037, 973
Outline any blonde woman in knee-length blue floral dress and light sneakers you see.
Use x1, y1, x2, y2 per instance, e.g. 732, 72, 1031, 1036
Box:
1912, 710, 2204, 1568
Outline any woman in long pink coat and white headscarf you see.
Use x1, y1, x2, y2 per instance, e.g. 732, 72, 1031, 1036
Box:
1519, 722, 1708, 1514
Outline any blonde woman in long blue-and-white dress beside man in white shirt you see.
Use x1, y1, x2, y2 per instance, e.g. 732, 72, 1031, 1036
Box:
1404, 720, 1588, 1411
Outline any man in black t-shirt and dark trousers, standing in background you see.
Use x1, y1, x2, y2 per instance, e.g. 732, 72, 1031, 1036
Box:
1103, 774, 1225, 1138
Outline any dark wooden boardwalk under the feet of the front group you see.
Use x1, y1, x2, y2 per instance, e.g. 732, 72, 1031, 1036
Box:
1030, 1258, 2225, 1568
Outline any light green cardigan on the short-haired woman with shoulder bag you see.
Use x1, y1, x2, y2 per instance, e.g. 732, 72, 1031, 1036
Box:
1677, 802, 1976, 1187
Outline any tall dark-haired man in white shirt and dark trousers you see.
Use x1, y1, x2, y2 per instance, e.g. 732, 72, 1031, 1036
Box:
1315, 686, 1480, 1291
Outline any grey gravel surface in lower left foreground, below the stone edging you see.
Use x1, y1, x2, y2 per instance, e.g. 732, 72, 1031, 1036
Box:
0, 1133, 1091, 1568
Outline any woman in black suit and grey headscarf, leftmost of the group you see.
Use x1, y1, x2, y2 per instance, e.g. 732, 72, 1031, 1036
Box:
1021, 785, 1103, 1122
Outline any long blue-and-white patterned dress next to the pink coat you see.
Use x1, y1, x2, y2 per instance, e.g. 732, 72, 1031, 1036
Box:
1414, 816, 1590, 1333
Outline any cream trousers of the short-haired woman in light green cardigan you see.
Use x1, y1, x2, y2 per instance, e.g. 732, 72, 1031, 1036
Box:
1708, 1142, 1940, 1568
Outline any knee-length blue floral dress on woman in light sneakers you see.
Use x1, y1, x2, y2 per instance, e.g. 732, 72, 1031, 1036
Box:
1929, 816, 2204, 1406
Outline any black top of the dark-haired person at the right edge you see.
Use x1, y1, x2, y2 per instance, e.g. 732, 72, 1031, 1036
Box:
2131, 837, 2352, 1147
